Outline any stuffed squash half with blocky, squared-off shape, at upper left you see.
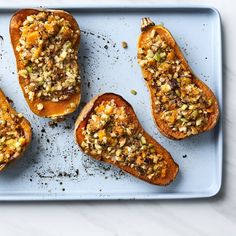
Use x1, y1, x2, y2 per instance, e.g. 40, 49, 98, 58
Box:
10, 9, 81, 118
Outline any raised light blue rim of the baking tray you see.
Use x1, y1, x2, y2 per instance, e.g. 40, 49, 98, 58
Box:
0, 1, 224, 202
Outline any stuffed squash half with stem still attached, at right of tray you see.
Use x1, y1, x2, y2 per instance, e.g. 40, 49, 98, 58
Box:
138, 18, 219, 139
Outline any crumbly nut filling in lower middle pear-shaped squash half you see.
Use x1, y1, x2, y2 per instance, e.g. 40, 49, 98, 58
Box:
81, 100, 168, 179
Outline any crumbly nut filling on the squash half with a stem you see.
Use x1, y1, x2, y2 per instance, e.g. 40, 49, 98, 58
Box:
138, 29, 213, 136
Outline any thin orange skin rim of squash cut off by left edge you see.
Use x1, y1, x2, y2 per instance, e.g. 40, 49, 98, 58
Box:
0, 89, 32, 171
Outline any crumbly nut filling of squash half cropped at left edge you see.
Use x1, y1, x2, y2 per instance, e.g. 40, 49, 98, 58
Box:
0, 104, 26, 164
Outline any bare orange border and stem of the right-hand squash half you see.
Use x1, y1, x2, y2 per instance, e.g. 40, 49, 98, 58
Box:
138, 18, 220, 140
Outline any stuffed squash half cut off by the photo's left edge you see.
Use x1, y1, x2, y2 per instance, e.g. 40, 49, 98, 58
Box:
0, 89, 32, 171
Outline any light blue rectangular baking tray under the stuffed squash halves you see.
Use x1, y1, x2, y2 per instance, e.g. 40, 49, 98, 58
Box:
0, 4, 223, 200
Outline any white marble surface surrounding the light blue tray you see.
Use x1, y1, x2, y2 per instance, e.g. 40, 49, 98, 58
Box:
0, 0, 236, 236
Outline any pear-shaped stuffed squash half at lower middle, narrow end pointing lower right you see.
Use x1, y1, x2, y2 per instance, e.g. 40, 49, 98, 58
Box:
75, 93, 179, 185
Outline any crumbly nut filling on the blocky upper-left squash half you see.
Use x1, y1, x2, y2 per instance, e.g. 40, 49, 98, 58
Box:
16, 12, 80, 102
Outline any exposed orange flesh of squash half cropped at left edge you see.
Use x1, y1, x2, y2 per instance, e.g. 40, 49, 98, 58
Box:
0, 89, 32, 171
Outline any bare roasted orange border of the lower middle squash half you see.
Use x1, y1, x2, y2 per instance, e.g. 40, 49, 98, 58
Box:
74, 93, 179, 186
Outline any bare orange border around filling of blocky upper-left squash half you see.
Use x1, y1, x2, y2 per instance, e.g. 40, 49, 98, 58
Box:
9, 9, 81, 119
